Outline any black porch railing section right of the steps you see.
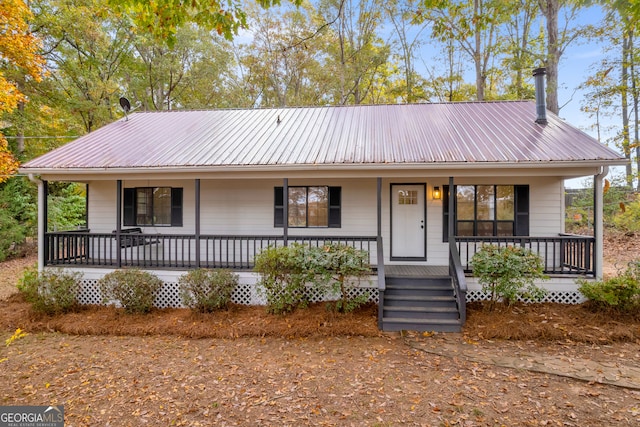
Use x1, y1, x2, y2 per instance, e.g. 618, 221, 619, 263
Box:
455, 234, 595, 276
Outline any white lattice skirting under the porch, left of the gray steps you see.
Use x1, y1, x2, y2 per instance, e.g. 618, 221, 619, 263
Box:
78, 279, 378, 308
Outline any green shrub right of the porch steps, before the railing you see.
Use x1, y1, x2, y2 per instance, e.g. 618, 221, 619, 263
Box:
470, 245, 546, 305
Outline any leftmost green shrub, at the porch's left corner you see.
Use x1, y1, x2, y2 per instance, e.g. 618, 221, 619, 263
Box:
18, 267, 82, 315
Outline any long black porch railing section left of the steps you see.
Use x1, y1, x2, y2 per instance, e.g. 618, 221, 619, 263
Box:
45, 230, 378, 270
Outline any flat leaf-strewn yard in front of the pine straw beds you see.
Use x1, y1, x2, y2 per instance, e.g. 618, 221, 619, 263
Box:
0, 332, 640, 426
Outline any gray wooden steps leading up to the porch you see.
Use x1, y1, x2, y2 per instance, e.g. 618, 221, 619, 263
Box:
382, 276, 462, 332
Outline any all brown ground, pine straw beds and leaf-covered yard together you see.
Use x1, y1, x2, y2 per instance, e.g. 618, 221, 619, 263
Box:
0, 232, 640, 426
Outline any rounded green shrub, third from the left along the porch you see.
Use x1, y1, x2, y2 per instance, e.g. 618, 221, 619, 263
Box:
178, 268, 238, 313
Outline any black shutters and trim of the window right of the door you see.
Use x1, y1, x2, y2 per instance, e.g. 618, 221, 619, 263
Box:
442, 184, 530, 242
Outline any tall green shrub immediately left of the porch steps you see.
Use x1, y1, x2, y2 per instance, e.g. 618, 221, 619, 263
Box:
322, 243, 371, 312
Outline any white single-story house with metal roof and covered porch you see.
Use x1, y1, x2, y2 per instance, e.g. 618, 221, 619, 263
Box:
20, 68, 625, 331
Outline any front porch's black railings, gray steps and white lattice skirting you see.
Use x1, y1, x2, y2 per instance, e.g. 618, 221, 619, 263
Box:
44, 230, 595, 331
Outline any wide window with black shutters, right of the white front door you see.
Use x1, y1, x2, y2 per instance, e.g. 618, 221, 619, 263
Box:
442, 185, 529, 241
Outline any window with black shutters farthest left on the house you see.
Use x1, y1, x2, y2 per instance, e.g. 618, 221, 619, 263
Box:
123, 187, 182, 227
